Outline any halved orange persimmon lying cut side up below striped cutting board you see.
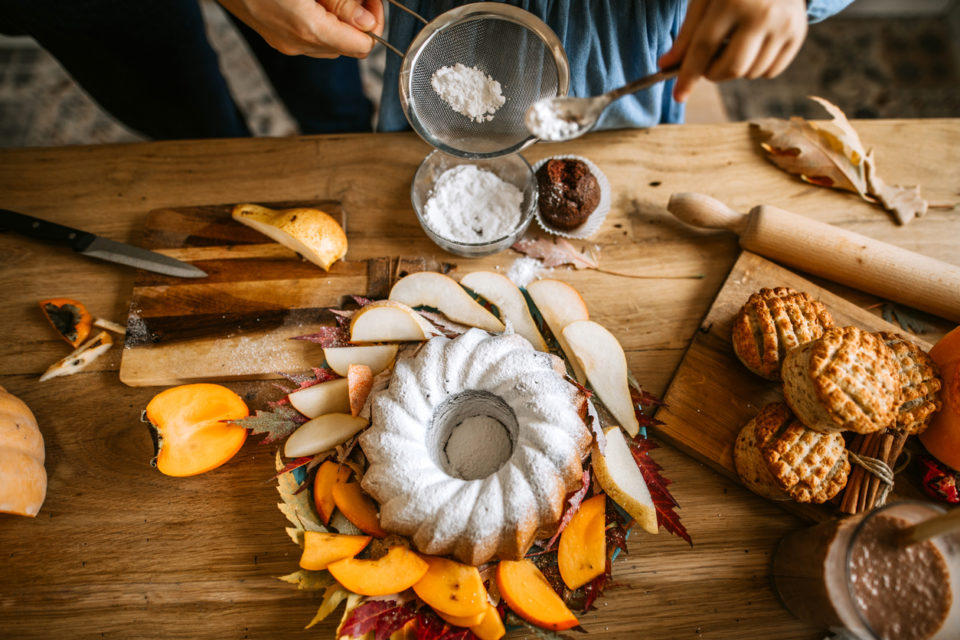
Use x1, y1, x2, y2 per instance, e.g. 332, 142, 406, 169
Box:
145, 383, 250, 476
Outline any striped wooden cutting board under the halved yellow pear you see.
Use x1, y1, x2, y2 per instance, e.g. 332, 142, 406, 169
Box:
120, 201, 439, 386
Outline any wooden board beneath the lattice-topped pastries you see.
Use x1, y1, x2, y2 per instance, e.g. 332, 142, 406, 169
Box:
656, 251, 930, 520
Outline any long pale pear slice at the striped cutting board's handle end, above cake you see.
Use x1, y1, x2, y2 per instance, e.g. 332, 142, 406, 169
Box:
389, 271, 504, 333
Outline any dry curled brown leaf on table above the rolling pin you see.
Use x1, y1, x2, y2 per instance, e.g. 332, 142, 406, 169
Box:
752, 96, 928, 224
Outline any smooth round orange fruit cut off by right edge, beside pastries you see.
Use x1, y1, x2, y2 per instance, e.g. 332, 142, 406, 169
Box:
919, 327, 960, 471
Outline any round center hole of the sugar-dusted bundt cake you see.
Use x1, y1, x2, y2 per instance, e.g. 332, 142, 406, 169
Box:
428, 391, 518, 480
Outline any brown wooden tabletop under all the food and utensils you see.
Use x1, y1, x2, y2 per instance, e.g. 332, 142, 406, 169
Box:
0, 120, 960, 640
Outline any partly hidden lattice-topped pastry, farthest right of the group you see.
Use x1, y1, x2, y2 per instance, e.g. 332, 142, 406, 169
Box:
877, 331, 943, 436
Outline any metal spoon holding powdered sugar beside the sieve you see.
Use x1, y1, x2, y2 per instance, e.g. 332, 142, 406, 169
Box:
524, 65, 680, 142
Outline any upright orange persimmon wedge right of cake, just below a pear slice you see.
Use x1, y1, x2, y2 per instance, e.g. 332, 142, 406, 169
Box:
557, 493, 607, 589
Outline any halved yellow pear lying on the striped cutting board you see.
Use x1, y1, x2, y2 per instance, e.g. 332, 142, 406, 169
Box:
232, 204, 347, 271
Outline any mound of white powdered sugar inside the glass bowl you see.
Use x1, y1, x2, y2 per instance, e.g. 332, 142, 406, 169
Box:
423, 164, 523, 243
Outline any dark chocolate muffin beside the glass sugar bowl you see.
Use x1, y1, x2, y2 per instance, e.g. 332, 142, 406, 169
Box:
537, 158, 600, 231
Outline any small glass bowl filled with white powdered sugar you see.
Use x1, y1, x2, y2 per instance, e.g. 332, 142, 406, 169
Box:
410, 150, 537, 258
